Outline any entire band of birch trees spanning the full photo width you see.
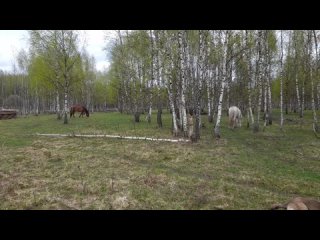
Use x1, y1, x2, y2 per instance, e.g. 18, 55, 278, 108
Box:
0, 30, 320, 141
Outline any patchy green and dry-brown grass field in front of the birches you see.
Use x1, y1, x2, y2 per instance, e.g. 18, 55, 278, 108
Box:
0, 109, 320, 209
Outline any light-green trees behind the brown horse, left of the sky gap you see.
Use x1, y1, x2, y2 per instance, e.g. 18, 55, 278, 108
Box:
0, 30, 112, 123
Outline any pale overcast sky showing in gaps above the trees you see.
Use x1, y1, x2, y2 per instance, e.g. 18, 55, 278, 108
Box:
0, 30, 115, 71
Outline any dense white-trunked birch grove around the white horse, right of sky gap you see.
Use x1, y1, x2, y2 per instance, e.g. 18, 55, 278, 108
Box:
110, 30, 320, 141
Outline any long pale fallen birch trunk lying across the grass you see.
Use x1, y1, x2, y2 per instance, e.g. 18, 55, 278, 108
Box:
36, 133, 190, 142
